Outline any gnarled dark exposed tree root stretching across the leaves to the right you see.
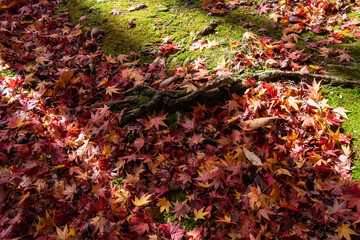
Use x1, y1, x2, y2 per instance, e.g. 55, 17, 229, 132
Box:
97, 70, 360, 124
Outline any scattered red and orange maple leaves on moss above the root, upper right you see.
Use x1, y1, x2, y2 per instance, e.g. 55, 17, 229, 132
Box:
198, 0, 360, 74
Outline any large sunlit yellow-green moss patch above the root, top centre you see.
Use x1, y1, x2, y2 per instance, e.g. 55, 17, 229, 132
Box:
58, 0, 282, 69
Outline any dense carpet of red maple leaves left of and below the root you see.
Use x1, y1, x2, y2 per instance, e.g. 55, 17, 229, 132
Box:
0, 0, 360, 239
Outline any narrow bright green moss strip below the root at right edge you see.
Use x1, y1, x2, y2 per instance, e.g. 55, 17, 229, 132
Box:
322, 86, 360, 180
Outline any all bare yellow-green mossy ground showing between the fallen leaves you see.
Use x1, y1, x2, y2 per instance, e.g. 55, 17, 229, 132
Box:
59, 0, 360, 180
